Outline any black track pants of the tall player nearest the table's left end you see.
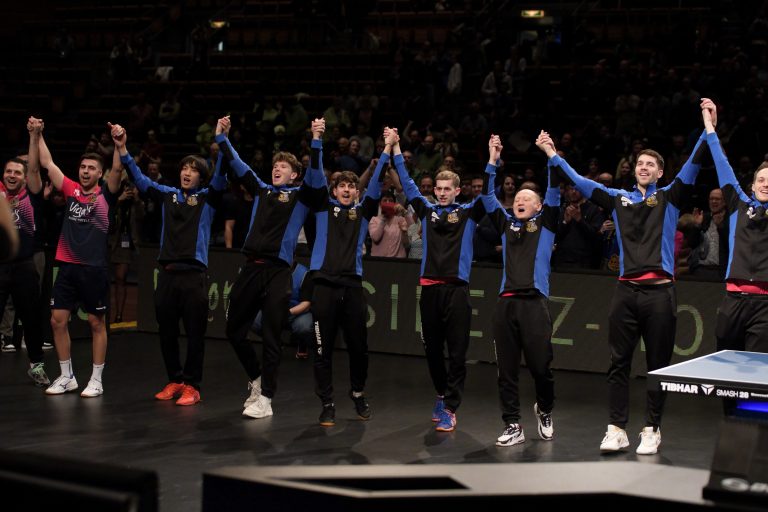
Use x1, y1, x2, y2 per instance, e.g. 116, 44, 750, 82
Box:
608, 281, 677, 428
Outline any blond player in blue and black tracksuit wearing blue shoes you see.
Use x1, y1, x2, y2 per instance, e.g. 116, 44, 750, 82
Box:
393, 129, 485, 432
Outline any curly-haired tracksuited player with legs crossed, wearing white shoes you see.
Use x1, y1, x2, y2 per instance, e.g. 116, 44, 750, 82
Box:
216, 119, 325, 418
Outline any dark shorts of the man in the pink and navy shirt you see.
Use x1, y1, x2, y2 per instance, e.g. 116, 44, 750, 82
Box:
51, 263, 109, 315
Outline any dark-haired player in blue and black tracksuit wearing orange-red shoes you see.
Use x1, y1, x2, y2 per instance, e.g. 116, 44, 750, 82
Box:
112, 120, 227, 405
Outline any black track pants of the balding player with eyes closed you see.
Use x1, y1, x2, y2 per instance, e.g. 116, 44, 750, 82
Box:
493, 295, 555, 424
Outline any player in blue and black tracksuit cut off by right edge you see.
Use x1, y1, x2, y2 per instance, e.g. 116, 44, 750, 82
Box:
705, 102, 768, 352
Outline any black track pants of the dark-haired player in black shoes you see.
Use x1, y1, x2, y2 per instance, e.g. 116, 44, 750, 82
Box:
312, 282, 368, 403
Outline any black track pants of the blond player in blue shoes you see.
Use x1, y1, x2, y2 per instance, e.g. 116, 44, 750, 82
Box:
419, 284, 472, 412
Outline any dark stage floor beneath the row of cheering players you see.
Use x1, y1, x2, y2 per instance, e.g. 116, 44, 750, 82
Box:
0, 332, 721, 512
